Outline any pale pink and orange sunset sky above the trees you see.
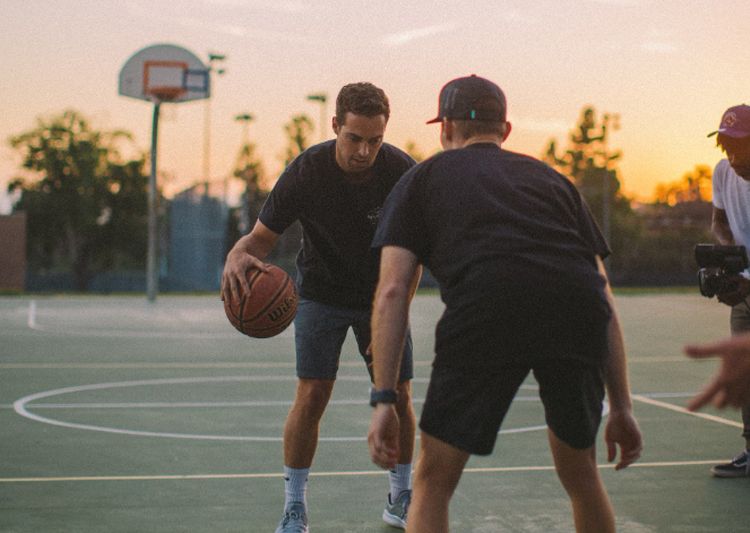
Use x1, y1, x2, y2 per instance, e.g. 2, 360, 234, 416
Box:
0, 0, 750, 213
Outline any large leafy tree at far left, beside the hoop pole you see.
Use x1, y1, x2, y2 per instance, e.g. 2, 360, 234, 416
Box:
8, 111, 148, 291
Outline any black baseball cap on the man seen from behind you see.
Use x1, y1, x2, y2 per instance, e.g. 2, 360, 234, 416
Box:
427, 74, 507, 124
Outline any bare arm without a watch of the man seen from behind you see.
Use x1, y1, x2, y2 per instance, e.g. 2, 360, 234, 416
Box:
597, 258, 643, 470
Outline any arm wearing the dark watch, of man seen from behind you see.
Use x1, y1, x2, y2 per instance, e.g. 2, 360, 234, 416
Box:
367, 246, 419, 469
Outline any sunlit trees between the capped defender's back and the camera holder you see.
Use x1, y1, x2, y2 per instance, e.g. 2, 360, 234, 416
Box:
542, 107, 713, 286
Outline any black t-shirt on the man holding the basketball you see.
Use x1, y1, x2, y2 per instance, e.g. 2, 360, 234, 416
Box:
259, 140, 415, 309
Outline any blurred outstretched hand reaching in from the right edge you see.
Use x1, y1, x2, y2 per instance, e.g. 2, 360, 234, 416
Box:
685, 334, 750, 411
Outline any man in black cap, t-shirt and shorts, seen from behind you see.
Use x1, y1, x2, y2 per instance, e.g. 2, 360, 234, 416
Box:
368, 76, 642, 533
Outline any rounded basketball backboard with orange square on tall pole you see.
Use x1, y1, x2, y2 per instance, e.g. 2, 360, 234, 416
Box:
119, 44, 211, 103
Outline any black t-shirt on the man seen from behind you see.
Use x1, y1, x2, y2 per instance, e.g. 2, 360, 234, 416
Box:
373, 143, 611, 360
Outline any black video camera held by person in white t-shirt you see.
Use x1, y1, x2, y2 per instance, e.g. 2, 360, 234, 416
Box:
695, 244, 750, 298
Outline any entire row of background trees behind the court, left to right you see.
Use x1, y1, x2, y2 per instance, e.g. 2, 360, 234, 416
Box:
8, 107, 713, 291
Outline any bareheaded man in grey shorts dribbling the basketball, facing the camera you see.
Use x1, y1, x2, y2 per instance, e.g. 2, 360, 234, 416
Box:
221, 83, 421, 533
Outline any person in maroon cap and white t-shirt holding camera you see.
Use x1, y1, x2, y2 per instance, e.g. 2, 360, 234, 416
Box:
708, 104, 750, 477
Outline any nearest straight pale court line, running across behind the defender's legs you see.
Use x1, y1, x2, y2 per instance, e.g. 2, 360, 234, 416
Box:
0, 459, 726, 483
